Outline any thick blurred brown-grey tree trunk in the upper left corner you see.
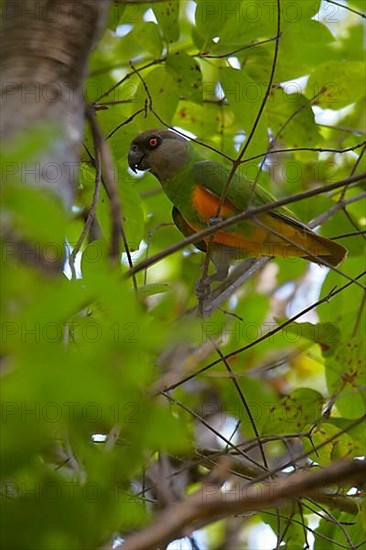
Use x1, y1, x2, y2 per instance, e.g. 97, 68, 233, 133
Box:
0, 0, 109, 270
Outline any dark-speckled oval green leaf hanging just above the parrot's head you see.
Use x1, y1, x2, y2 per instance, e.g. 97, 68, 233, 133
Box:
166, 52, 202, 103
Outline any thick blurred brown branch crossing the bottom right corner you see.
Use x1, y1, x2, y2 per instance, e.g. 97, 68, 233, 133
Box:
111, 460, 366, 550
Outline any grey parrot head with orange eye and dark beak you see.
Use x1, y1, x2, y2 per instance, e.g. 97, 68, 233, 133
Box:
128, 129, 190, 181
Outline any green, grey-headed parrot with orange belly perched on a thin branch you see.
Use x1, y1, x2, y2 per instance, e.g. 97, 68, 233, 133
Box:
128, 129, 347, 280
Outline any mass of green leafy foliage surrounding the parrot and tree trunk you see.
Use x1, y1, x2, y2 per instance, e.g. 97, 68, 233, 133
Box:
1, 0, 366, 550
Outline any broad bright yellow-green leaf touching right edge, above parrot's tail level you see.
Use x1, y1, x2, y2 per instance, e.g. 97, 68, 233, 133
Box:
305, 61, 366, 110
